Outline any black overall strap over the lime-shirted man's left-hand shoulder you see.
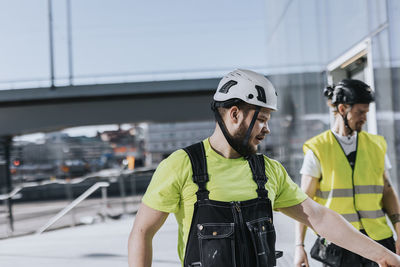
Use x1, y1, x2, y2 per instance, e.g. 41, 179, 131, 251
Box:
183, 142, 210, 201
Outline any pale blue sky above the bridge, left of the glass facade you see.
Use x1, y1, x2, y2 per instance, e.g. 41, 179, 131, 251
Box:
0, 0, 272, 88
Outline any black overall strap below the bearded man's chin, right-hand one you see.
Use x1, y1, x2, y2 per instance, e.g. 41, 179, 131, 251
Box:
247, 154, 268, 198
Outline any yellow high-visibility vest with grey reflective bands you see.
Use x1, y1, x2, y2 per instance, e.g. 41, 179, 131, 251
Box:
303, 130, 393, 240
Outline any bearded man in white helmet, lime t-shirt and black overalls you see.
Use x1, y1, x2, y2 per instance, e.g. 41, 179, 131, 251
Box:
128, 70, 400, 267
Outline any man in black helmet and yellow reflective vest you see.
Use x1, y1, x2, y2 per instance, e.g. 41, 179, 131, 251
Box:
295, 79, 400, 267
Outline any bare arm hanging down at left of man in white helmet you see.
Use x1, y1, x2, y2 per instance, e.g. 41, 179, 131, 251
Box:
128, 203, 168, 267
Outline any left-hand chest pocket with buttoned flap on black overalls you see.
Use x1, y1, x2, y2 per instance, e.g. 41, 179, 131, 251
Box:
197, 223, 236, 267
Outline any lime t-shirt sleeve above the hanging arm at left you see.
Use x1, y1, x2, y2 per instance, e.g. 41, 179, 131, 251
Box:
142, 150, 188, 213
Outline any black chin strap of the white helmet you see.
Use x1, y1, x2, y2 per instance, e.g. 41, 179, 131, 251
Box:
212, 105, 261, 159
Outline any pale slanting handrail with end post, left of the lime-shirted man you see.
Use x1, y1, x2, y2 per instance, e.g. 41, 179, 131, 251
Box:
36, 182, 110, 235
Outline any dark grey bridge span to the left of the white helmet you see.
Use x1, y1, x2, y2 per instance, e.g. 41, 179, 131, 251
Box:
0, 79, 218, 135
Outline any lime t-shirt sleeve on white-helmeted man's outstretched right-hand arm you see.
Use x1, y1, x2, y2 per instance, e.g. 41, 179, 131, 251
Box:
273, 160, 307, 209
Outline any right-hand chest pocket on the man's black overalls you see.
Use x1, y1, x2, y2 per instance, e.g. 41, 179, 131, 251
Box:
246, 217, 276, 267
